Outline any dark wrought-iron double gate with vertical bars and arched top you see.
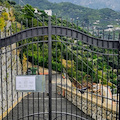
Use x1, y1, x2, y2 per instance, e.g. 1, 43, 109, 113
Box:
0, 17, 120, 120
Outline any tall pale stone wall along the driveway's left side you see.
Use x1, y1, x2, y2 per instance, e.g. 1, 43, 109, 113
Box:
0, 44, 25, 119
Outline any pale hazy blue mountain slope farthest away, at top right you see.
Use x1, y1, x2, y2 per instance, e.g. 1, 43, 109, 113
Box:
49, 0, 120, 11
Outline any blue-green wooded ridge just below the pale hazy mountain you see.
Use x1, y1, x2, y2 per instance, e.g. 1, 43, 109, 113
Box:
14, 0, 120, 26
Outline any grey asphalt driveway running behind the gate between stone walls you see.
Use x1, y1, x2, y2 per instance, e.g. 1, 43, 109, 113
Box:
4, 75, 92, 120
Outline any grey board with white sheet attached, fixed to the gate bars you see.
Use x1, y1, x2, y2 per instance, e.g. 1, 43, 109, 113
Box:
16, 75, 46, 92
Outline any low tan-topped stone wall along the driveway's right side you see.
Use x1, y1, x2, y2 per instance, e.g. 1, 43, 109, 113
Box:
57, 86, 118, 120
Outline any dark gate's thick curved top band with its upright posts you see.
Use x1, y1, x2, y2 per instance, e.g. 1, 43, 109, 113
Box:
0, 16, 120, 120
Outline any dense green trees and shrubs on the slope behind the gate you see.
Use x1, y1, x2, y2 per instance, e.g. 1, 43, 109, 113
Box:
0, 1, 117, 87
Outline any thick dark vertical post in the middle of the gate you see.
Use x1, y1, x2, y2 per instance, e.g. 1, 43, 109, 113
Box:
48, 16, 52, 120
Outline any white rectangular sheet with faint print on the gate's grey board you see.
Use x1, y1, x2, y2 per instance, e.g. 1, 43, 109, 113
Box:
16, 76, 36, 91
